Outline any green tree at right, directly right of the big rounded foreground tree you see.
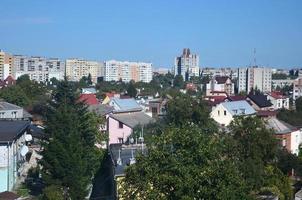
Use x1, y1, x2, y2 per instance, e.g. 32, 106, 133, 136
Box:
226, 117, 291, 199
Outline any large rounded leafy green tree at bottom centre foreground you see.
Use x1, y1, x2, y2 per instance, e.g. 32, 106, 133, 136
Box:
119, 125, 249, 200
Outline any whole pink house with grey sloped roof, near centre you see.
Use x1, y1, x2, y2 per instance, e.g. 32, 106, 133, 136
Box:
107, 112, 153, 145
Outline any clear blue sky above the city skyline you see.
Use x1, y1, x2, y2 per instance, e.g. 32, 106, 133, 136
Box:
0, 0, 302, 68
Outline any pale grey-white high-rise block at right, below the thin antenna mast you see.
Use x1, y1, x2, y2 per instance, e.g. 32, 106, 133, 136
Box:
237, 66, 272, 93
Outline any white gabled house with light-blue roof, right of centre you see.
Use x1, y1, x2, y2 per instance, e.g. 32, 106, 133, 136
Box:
210, 100, 256, 126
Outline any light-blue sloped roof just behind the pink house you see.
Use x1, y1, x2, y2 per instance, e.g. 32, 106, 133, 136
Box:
111, 97, 142, 112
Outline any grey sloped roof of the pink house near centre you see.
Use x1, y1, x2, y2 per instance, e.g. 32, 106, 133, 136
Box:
110, 112, 154, 128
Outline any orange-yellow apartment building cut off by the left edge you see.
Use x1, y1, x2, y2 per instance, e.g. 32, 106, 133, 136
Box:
0, 50, 14, 80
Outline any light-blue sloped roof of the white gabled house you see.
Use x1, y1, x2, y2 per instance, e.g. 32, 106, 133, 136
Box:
221, 100, 256, 116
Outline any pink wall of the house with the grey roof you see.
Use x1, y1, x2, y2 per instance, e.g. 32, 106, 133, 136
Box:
108, 117, 132, 144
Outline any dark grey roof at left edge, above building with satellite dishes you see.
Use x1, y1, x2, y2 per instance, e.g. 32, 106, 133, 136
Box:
0, 120, 30, 143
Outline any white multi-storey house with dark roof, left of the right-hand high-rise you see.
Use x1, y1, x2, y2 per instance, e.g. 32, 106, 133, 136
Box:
206, 76, 235, 96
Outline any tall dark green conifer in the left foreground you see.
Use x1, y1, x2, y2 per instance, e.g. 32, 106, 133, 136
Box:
41, 81, 103, 199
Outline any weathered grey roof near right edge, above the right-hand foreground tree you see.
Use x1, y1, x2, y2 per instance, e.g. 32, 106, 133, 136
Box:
265, 117, 297, 134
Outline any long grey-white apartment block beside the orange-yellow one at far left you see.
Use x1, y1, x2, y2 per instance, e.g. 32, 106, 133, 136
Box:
13, 55, 65, 82
